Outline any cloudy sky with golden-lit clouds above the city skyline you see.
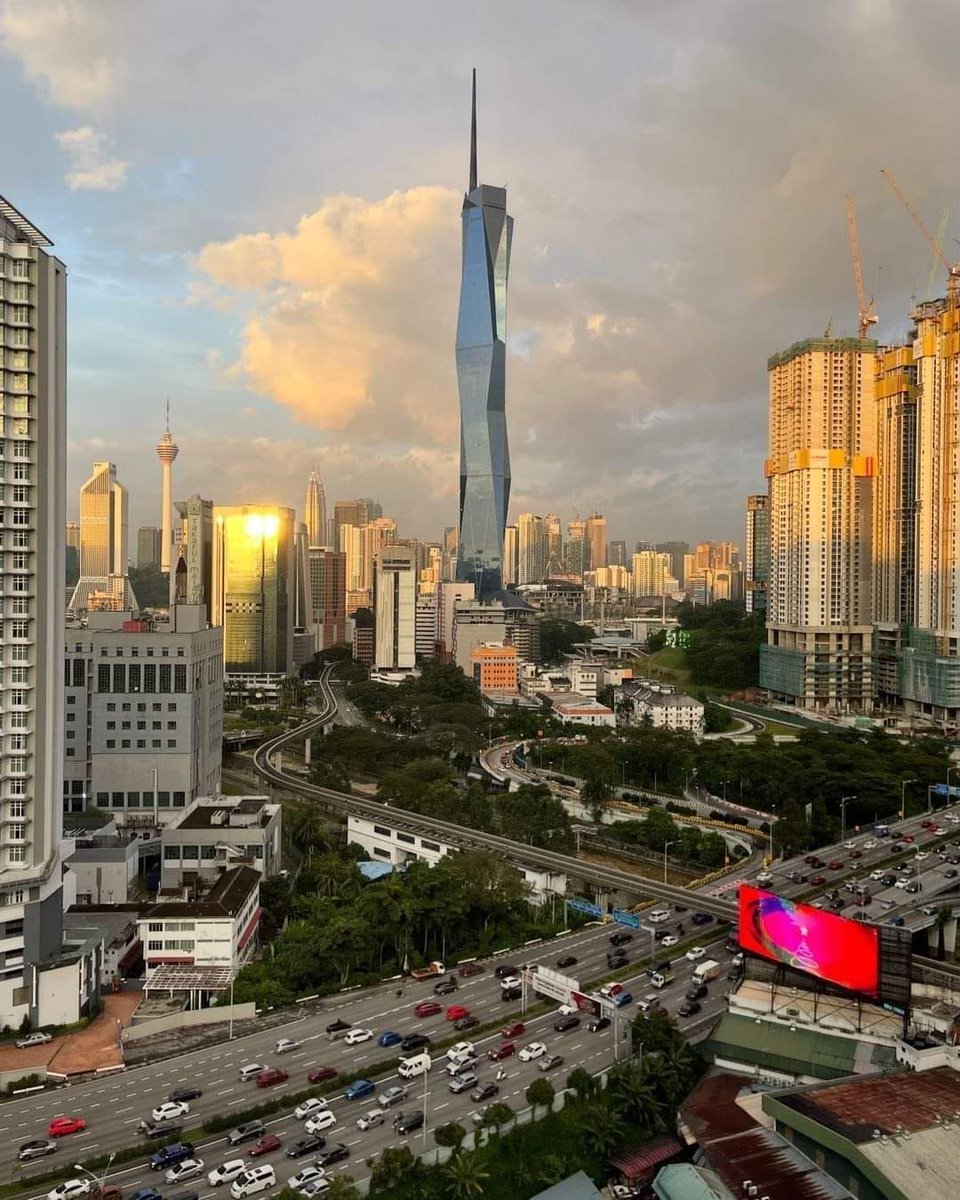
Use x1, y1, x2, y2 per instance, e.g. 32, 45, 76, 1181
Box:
0, 0, 960, 541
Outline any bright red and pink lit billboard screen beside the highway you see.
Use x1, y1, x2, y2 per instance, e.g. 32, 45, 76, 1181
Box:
739, 884, 881, 1000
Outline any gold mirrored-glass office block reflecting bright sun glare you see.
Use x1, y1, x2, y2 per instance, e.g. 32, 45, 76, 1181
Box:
212, 504, 296, 686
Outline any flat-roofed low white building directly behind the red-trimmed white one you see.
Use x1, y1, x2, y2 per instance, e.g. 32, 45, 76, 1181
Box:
160, 796, 282, 888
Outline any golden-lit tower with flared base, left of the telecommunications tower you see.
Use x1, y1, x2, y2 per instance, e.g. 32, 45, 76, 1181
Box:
70, 462, 137, 612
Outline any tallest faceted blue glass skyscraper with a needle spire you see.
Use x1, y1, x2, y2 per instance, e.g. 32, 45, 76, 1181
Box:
457, 71, 514, 600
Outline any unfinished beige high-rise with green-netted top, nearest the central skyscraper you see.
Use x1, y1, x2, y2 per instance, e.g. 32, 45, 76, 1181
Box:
760, 337, 877, 713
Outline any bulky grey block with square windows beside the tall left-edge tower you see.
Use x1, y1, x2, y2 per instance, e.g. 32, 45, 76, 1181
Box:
62, 605, 223, 826
